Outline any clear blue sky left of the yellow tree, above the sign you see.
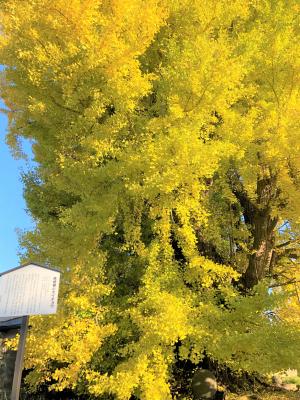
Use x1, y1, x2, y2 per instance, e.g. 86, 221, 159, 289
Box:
0, 83, 33, 272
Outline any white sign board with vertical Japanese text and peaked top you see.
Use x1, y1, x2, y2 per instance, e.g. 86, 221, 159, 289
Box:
0, 264, 60, 318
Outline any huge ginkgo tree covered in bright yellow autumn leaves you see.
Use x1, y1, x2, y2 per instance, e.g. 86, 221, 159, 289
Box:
0, 0, 300, 400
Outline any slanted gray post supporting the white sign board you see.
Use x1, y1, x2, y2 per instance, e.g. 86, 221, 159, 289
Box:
11, 315, 29, 400
